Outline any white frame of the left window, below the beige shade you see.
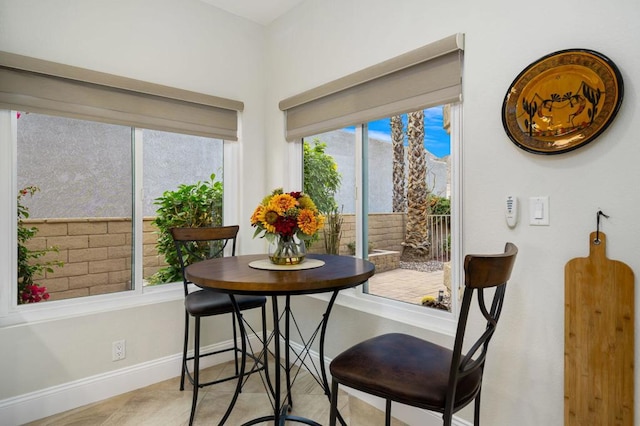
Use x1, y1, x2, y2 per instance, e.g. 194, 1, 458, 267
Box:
0, 109, 240, 327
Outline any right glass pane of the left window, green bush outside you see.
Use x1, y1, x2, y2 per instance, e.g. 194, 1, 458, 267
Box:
137, 130, 224, 285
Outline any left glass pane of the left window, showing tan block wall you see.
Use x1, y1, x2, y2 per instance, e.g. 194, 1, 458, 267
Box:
16, 112, 133, 302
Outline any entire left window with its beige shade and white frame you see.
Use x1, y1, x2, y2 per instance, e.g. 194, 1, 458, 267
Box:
0, 52, 244, 324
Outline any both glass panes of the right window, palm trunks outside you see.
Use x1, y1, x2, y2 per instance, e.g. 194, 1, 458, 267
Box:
304, 106, 458, 311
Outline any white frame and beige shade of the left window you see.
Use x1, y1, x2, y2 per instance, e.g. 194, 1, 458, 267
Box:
0, 51, 244, 327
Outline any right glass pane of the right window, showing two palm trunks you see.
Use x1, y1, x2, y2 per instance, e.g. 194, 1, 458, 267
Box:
363, 106, 455, 310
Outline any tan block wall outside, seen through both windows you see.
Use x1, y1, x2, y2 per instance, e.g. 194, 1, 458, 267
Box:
25, 213, 405, 300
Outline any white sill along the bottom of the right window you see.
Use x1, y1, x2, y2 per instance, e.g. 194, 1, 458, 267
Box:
309, 286, 457, 336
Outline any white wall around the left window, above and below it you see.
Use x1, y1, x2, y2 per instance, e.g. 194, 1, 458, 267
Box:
0, 0, 267, 424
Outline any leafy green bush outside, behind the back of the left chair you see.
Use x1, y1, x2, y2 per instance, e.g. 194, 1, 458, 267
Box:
148, 173, 223, 284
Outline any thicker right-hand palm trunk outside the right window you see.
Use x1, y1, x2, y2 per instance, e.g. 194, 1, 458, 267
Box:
402, 110, 429, 260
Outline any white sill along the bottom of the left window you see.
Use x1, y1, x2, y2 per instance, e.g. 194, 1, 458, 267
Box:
0, 283, 184, 327
